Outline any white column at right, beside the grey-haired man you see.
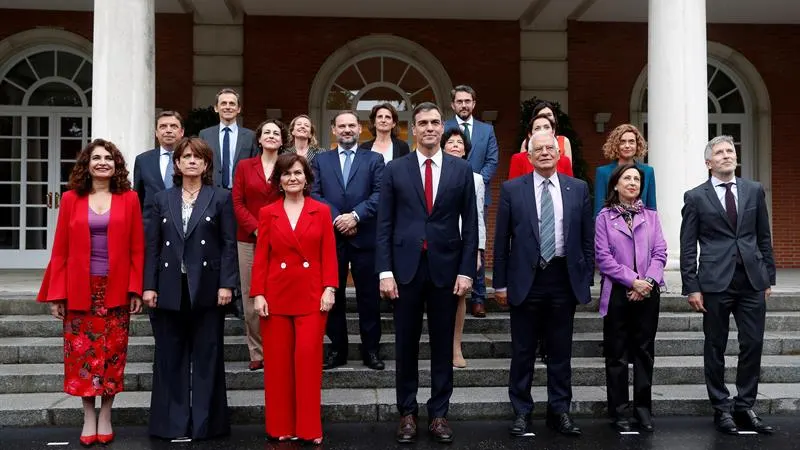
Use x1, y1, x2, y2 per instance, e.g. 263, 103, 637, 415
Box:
647, 0, 708, 292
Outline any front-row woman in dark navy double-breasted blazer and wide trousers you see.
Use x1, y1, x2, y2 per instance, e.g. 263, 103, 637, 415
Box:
143, 138, 239, 439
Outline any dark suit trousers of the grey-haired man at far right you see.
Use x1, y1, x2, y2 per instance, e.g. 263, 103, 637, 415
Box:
703, 264, 767, 412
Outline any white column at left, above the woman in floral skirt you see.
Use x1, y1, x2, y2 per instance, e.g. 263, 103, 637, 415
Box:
92, 0, 155, 172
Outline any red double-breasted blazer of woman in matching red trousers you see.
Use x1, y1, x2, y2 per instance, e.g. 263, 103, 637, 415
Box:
250, 197, 339, 316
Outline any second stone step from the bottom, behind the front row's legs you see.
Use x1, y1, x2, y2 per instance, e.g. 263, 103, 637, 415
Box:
0, 355, 800, 394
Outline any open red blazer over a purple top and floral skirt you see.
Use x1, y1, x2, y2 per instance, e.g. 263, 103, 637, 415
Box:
36, 191, 144, 311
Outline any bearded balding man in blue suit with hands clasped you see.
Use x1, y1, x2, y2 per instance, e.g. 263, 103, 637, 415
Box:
311, 111, 384, 370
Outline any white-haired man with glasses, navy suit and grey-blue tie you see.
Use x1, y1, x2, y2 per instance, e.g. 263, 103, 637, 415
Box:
494, 132, 594, 436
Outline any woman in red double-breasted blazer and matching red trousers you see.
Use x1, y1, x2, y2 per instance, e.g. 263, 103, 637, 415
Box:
250, 153, 338, 445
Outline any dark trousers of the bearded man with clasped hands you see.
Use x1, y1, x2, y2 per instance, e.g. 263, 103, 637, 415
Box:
326, 242, 381, 358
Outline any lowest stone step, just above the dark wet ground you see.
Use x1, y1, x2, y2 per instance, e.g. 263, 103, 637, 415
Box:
0, 383, 800, 427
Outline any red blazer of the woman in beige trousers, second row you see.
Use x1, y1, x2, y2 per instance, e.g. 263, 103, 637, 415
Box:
231, 156, 281, 243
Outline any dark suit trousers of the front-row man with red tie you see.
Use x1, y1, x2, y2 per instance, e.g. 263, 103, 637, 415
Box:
394, 252, 458, 418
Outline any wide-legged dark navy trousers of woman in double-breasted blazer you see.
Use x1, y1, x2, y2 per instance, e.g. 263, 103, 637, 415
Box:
149, 275, 230, 439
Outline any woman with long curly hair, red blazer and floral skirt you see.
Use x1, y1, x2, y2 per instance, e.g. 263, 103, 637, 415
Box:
36, 139, 144, 446
